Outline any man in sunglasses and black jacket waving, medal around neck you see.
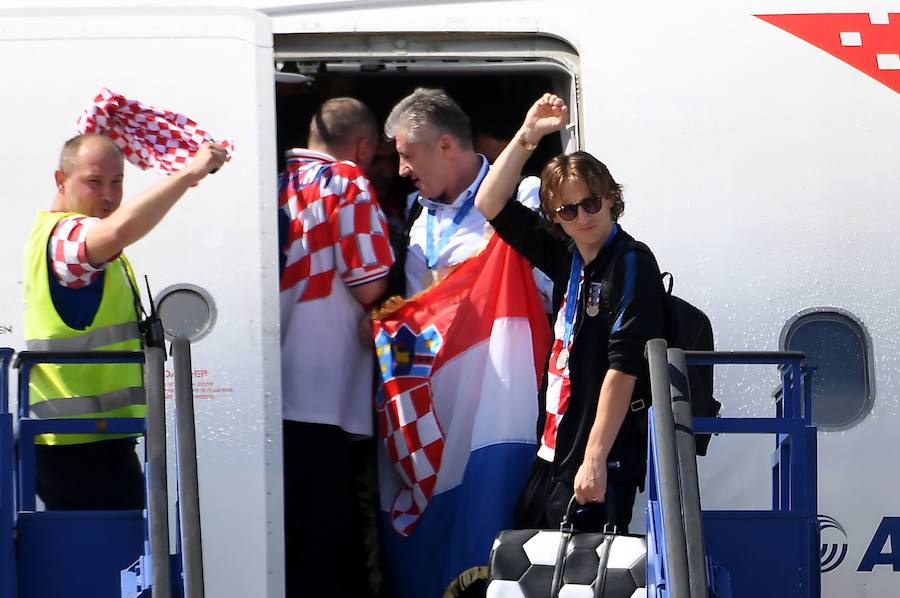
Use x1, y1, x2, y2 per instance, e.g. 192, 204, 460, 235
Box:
475, 94, 663, 531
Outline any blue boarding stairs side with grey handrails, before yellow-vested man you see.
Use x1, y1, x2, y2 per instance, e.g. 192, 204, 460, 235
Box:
0, 339, 204, 598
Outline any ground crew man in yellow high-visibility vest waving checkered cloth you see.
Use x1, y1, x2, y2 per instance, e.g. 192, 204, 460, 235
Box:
24, 133, 225, 510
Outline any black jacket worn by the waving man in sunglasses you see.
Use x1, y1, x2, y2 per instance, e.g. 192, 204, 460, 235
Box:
491, 202, 664, 486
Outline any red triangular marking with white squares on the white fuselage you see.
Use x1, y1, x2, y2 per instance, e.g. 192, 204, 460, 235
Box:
756, 13, 900, 93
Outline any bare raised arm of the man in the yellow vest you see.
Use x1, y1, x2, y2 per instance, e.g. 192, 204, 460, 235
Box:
85, 143, 225, 264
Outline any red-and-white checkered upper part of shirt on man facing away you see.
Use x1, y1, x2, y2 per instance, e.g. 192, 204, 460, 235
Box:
278, 151, 394, 302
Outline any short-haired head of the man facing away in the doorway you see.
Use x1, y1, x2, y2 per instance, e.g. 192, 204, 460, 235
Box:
308, 98, 379, 168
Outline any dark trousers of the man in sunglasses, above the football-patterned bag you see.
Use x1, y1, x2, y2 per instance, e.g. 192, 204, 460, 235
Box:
514, 459, 637, 534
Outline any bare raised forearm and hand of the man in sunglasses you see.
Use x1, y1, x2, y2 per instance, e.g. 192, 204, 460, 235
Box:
475, 93, 569, 220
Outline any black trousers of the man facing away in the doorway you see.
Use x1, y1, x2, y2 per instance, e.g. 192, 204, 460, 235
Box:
283, 420, 371, 598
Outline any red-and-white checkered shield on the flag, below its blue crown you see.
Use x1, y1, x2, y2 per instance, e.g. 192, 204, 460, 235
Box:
378, 377, 444, 536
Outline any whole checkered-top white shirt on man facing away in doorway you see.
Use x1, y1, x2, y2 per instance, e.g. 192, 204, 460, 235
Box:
278, 150, 394, 435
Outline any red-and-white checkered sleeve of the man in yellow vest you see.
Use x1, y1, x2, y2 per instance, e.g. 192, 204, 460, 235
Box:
47, 216, 119, 289
